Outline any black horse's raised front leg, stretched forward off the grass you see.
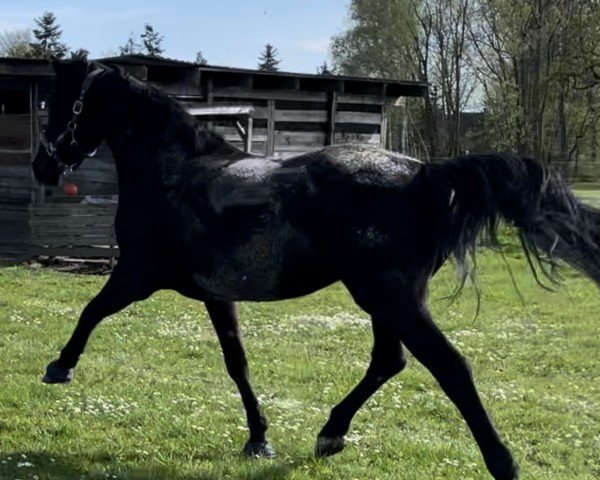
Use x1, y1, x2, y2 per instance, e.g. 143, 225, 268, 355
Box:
42, 263, 154, 383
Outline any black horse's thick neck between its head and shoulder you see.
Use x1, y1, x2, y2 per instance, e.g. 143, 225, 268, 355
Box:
107, 78, 232, 205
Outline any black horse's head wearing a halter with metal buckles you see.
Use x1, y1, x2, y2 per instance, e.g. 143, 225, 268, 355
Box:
33, 60, 111, 185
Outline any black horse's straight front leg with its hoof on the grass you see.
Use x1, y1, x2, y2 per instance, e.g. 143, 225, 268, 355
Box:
205, 300, 274, 458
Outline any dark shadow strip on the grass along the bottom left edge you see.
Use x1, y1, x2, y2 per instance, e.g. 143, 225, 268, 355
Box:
0, 451, 308, 480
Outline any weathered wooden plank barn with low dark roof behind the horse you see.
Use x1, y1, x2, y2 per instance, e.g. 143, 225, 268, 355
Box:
0, 55, 427, 261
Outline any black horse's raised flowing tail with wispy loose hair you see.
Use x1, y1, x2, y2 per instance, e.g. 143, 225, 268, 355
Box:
424, 153, 600, 290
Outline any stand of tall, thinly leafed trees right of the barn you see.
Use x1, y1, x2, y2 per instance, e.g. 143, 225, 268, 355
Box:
331, 0, 600, 175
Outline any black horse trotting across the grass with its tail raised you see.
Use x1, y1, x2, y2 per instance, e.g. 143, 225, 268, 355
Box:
33, 61, 600, 480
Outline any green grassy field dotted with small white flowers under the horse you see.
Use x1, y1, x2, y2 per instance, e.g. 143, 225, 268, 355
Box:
0, 223, 600, 480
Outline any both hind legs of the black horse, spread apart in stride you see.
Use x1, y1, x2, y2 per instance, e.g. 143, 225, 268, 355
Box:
330, 275, 519, 480
